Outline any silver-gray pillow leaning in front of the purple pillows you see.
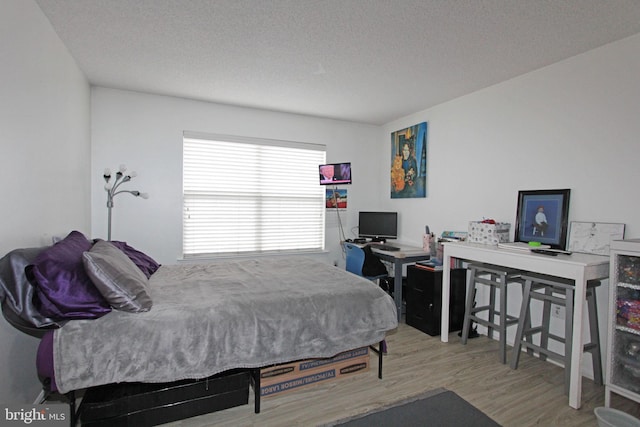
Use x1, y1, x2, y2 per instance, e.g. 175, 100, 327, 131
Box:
82, 240, 153, 313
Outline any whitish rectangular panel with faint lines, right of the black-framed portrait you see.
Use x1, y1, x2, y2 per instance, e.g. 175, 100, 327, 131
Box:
569, 221, 624, 256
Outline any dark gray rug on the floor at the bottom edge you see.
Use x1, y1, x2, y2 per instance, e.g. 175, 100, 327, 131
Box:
327, 388, 500, 427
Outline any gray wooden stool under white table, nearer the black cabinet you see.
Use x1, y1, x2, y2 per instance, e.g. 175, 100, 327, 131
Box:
460, 263, 523, 363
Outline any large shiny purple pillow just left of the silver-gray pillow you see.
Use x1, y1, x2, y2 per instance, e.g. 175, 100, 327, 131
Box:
25, 231, 111, 320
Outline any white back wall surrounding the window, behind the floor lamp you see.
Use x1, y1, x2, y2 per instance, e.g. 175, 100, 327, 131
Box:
91, 87, 380, 264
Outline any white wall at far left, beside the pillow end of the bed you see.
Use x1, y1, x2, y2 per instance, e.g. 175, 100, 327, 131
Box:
0, 0, 90, 403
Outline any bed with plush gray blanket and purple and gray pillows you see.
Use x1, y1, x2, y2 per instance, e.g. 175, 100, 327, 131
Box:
0, 232, 397, 422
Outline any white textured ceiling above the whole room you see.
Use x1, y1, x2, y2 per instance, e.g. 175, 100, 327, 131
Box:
36, 0, 640, 124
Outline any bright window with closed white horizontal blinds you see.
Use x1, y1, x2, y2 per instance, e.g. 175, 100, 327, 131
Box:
183, 133, 326, 257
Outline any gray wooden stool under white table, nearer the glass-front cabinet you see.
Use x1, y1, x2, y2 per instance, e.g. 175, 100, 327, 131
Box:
511, 273, 602, 393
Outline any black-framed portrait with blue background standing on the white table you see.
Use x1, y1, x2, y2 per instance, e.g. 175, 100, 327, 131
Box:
514, 189, 571, 250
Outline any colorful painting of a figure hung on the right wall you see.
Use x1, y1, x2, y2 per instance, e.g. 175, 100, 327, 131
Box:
391, 122, 427, 199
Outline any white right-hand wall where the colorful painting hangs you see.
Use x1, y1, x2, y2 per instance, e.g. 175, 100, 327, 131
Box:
379, 35, 640, 375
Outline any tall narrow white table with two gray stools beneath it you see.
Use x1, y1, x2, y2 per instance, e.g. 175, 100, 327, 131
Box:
440, 242, 609, 409
